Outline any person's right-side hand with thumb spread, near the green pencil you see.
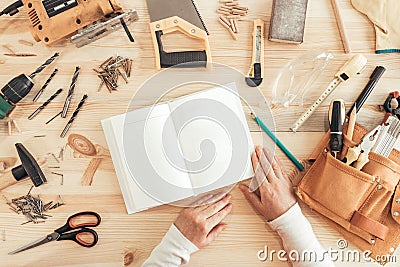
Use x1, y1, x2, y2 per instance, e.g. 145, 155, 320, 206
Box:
240, 146, 296, 221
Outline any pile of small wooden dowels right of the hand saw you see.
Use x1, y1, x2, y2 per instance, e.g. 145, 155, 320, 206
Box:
217, 0, 249, 40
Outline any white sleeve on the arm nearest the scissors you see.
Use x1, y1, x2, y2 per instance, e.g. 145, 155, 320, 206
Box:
142, 225, 199, 267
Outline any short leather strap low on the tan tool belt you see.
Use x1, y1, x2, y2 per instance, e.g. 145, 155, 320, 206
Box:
350, 211, 389, 240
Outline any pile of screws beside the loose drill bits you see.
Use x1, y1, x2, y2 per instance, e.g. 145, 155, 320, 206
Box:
93, 56, 133, 93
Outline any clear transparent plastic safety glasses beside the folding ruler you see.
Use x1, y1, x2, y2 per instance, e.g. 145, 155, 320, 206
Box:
272, 50, 333, 107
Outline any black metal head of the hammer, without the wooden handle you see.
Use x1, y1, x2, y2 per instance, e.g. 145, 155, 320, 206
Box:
12, 143, 47, 187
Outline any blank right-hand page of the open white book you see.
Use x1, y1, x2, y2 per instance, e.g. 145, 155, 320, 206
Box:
169, 84, 254, 195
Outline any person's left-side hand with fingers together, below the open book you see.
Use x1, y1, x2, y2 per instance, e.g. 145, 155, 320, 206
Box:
174, 195, 232, 249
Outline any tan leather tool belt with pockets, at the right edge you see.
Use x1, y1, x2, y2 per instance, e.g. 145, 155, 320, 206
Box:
296, 125, 400, 264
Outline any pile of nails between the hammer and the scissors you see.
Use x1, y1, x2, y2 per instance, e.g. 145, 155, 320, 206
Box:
3, 186, 65, 225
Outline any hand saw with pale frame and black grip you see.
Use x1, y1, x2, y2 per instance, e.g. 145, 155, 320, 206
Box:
146, 0, 211, 69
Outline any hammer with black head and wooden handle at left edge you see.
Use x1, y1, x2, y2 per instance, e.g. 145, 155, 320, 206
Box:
0, 143, 47, 191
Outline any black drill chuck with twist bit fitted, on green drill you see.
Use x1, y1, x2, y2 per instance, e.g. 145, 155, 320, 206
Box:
1, 53, 60, 104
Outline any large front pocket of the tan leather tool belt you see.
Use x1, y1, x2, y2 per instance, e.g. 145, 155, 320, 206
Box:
297, 149, 375, 237
